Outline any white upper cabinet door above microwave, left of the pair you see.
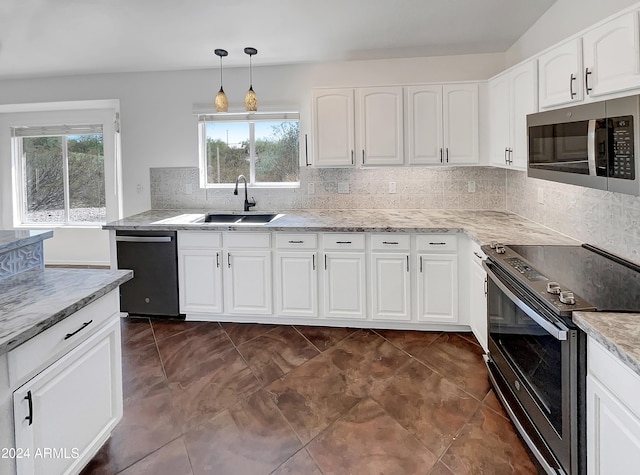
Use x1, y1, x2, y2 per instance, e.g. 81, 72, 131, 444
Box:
538, 38, 584, 109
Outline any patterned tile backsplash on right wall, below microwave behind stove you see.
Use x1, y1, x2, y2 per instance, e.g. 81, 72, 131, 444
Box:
506, 170, 640, 263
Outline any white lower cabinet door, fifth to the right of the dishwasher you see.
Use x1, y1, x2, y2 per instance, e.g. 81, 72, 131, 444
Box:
370, 253, 411, 321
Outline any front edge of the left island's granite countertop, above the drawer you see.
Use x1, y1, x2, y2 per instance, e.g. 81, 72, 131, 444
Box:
0, 270, 133, 354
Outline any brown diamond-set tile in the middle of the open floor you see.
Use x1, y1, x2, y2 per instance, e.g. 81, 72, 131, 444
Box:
267, 353, 361, 444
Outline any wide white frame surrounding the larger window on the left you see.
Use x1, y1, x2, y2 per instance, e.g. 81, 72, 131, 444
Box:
0, 107, 123, 229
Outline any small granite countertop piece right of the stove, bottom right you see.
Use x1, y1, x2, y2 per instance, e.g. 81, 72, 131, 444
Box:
572, 312, 640, 376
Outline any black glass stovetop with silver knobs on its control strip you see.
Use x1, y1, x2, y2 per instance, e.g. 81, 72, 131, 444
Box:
482, 244, 640, 315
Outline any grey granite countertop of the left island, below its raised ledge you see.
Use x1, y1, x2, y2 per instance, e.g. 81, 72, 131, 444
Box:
0, 269, 133, 354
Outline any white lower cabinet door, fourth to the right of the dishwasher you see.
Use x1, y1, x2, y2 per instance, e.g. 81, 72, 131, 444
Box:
323, 252, 367, 319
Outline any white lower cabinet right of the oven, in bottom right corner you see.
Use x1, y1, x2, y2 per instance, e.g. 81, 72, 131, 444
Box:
587, 338, 640, 475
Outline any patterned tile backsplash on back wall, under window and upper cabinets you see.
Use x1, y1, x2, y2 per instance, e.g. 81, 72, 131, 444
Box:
151, 167, 506, 210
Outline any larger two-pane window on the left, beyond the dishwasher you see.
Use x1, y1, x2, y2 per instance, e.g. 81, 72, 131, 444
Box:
12, 125, 106, 224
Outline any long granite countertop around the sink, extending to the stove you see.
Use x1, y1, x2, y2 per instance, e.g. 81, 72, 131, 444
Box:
103, 209, 578, 244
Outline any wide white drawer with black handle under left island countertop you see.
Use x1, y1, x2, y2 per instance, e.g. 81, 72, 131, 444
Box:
7, 289, 120, 387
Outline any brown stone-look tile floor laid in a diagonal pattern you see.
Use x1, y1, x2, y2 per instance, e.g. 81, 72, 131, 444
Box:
83, 318, 536, 475
